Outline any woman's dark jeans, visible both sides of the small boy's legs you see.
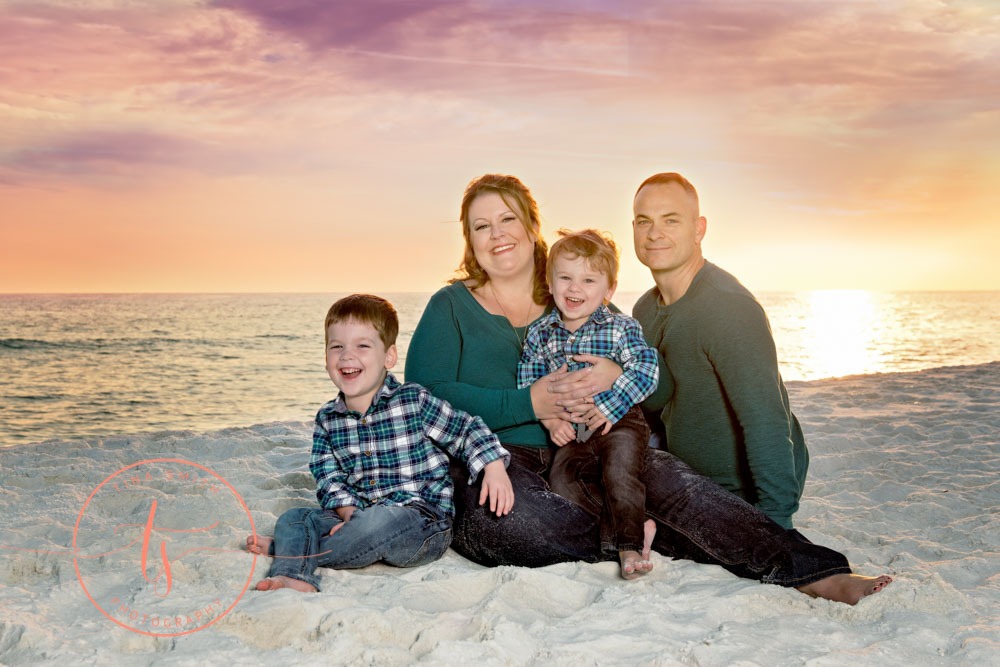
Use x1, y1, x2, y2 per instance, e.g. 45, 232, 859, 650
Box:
451, 444, 851, 586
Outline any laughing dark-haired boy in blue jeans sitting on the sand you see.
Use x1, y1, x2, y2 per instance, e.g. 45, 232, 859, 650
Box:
247, 294, 514, 592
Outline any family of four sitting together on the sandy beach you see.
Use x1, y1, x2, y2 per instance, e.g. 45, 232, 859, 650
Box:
247, 173, 892, 604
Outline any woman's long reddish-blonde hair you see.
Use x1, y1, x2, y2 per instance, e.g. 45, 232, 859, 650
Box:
449, 174, 550, 305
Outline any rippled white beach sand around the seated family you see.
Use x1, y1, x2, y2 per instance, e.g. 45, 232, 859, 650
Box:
0, 363, 1000, 665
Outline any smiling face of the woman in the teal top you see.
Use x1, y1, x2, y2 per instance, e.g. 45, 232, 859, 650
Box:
469, 192, 535, 280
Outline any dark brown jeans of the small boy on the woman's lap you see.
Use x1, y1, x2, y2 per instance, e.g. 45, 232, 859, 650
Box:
549, 406, 649, 556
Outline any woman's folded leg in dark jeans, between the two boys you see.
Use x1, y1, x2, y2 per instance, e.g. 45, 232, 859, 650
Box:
451, 444, 609, 567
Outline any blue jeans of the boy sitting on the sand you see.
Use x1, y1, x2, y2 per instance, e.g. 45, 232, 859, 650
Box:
267, 501, 451, 590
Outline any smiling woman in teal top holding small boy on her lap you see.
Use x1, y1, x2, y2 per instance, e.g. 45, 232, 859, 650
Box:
406, 174, 891, 604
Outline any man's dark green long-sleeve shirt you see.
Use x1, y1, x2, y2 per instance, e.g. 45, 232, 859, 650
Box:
632, 262, 809, 528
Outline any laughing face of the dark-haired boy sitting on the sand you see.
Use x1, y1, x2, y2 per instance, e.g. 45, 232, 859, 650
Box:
326, 320, 396, 413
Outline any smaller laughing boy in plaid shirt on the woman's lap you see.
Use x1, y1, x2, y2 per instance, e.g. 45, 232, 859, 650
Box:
518, 229, 659, 579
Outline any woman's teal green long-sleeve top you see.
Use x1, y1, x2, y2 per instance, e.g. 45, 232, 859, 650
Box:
405, 282, 551, 447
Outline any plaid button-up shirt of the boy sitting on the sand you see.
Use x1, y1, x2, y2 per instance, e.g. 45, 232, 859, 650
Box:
309, 373, 510, 516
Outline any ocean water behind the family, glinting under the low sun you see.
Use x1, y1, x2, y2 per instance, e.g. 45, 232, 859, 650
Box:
0, 291, 1000, 447
